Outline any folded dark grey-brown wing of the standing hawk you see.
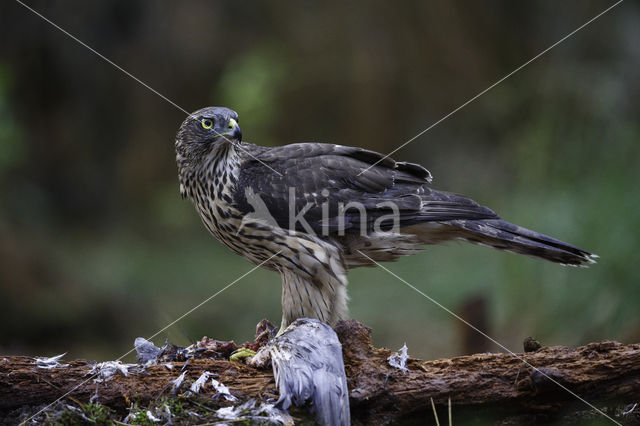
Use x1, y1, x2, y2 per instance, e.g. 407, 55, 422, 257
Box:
234, 143, 496, 233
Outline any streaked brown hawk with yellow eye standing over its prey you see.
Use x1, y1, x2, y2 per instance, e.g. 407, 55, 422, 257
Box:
175, 107, 597, 331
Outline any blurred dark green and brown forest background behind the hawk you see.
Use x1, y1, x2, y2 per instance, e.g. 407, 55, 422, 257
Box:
0, 0, 640, 360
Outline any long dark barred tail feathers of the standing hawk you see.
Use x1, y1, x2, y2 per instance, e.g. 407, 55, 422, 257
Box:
440, 219, 598, 266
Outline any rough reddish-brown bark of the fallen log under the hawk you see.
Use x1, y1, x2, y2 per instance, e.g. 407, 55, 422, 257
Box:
0, 320, 640, 423
